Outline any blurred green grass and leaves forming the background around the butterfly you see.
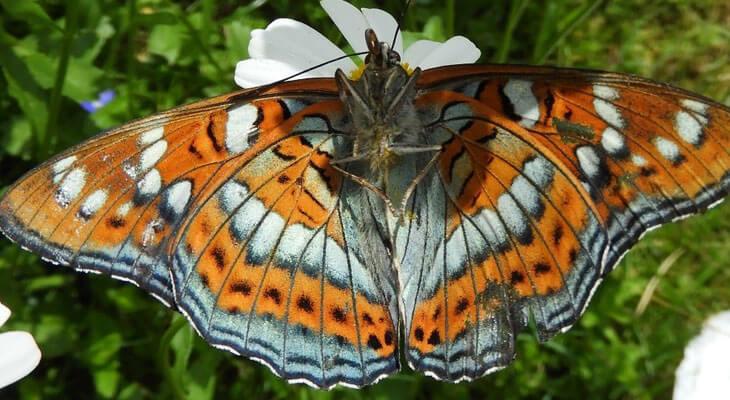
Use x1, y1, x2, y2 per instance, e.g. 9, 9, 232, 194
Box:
0, 0, 730, 400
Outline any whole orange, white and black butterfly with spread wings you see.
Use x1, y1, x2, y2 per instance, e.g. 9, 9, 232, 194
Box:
0, 21, 730, 388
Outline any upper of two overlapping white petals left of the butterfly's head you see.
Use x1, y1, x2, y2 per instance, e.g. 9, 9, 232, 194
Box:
248, 18, 349, 72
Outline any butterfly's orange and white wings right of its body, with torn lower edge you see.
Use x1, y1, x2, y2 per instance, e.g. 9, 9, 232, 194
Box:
395, 66, 730, 381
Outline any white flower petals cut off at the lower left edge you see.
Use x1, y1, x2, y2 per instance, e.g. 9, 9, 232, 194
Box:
0, 303, 41, 389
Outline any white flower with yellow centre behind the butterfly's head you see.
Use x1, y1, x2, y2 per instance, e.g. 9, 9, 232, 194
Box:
235, 0, 481, 88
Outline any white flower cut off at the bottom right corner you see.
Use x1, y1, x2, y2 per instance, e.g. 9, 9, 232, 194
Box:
674, 311, 730, 400
